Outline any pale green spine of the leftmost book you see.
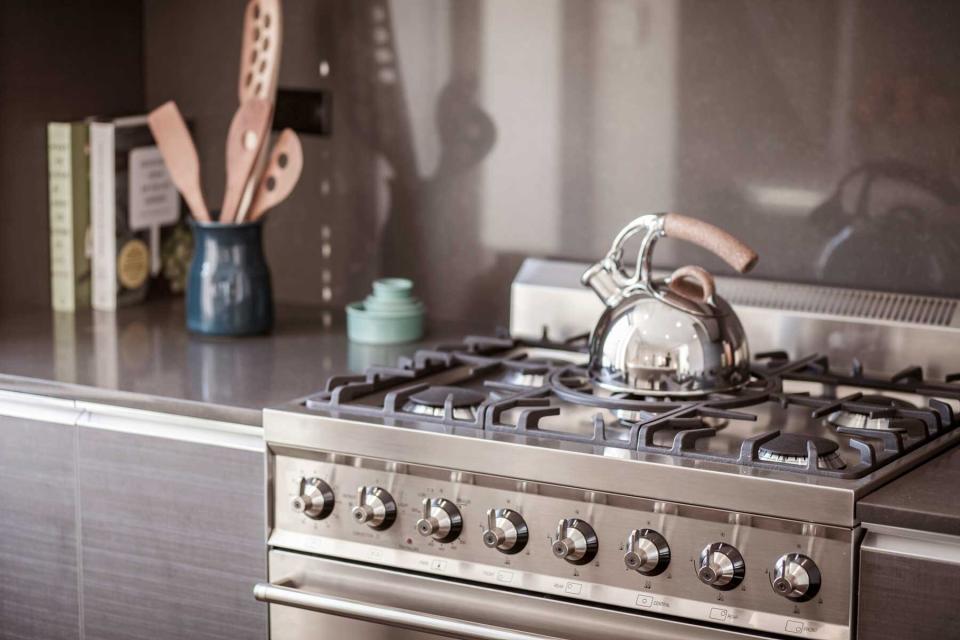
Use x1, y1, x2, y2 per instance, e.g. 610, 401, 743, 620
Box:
47, 122, 76, 311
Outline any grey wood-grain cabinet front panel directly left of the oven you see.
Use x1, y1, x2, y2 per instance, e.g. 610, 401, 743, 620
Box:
79, 428, 267, 640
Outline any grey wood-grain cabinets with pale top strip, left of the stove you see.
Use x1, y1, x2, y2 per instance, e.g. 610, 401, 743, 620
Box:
0, 391, 267, 640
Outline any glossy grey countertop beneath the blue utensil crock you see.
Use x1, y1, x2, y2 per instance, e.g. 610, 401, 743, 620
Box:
0, 299, 494, 425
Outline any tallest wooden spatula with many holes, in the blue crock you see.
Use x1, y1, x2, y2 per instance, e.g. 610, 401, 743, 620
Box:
237, 0, 283, 222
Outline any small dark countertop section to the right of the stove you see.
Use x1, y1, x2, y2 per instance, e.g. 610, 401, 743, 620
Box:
857, 446, 960, 535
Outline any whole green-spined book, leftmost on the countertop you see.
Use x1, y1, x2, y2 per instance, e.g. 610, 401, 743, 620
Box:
47, 122, 91, 312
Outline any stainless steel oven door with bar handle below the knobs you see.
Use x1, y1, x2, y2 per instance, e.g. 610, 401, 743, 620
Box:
254, 550, 753, 640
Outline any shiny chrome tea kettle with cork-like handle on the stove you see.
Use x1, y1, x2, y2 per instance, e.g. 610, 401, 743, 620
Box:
581, 213, 757, 396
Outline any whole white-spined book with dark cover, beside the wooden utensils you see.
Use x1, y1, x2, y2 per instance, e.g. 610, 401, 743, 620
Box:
90, 116, 180, 311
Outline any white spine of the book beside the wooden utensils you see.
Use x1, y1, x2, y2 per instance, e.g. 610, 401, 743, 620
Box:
90, 122, 117, 311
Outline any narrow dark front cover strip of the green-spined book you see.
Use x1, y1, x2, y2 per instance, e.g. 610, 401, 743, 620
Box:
70, 122, 92, 309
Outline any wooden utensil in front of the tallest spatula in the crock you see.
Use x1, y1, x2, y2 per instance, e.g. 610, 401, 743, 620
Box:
220, 98, 273, 223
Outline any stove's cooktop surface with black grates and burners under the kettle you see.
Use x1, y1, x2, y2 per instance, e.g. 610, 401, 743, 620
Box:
304, 337, 960, 480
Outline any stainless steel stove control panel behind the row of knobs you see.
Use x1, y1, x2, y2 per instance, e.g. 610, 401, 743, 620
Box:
269, 448, 857, 639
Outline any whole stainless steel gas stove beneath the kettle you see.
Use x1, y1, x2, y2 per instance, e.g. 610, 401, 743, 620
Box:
256, 258, 960, 639
